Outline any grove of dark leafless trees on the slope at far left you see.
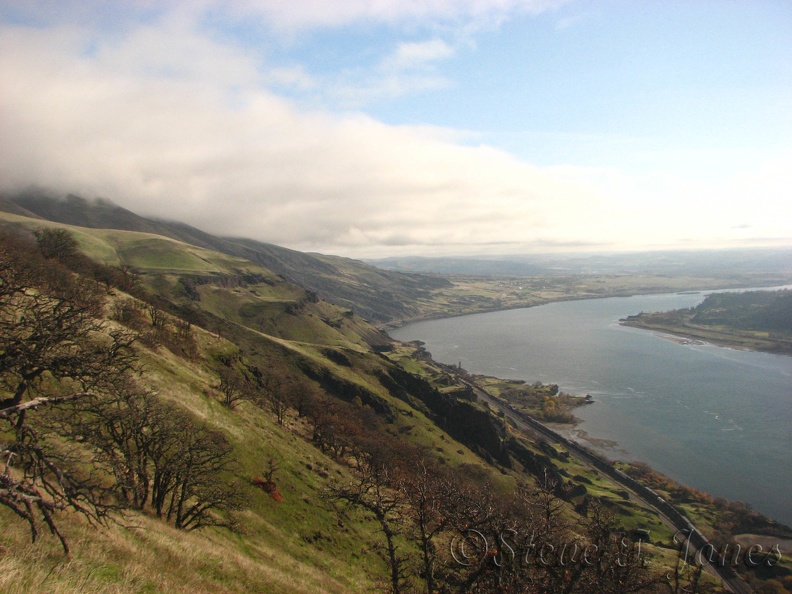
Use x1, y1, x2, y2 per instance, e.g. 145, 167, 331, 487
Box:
0, 228, 237, 553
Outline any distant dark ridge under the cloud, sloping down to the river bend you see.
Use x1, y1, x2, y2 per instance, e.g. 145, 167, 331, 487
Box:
0, 189, 451, 324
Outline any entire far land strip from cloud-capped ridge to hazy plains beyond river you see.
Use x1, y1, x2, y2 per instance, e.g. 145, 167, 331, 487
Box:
7, 189, 792, 327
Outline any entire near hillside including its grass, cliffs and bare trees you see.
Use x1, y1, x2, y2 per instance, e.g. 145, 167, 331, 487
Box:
0, 206, 788, 594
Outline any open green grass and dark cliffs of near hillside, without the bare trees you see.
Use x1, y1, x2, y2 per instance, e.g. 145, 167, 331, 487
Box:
0, 205, 788, 592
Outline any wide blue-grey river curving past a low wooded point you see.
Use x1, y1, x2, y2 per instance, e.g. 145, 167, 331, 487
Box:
389, 293, 792, 525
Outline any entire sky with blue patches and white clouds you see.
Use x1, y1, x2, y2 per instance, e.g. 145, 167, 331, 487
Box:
0, 0, 792, 257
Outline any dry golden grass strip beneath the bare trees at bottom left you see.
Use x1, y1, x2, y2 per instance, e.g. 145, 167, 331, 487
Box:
0, 510, 372, 594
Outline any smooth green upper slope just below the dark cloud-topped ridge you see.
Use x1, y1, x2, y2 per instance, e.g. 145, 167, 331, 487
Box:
0, 213, 389, 349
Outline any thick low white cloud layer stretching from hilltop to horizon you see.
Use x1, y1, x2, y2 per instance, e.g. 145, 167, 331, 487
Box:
0, 0, 792, 256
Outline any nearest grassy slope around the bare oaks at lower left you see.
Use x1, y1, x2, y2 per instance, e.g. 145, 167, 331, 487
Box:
0, 320, 384, 593
